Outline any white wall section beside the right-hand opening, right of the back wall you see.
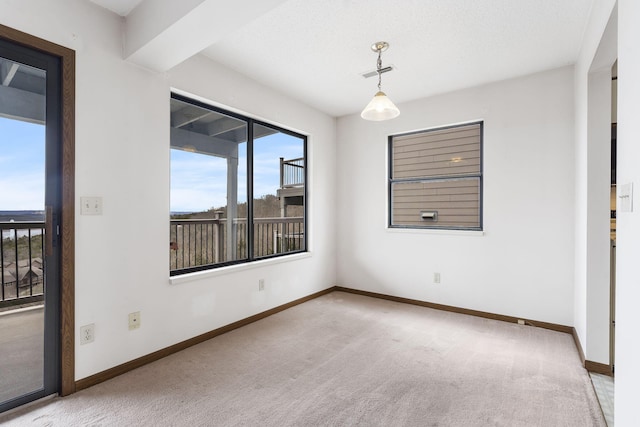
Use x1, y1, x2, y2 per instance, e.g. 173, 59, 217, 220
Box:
574, 0, 617, 365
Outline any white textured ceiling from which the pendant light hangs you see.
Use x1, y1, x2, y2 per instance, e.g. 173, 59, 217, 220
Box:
87, 0, 593, 116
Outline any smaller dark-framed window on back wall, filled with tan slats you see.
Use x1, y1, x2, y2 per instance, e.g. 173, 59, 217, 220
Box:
389, 122, 483, 230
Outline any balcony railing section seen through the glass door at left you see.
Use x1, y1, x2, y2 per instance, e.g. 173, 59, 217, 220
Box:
0, 221, 44, 308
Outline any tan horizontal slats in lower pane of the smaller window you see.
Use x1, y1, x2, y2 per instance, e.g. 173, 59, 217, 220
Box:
391, 178, 480, 228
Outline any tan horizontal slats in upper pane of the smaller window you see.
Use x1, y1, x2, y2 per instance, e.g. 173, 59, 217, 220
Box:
391, 123, 480, 179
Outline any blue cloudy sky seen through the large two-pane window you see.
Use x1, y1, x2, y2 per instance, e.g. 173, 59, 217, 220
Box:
171, 133, 303, 212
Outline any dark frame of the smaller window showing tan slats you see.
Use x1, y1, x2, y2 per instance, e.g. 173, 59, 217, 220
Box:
387, 120, 484, 232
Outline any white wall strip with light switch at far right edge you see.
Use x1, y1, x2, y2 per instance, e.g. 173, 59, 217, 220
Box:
615, 0, 640, 426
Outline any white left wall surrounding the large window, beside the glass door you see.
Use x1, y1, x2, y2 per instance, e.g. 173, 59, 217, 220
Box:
0, 0, 336, 379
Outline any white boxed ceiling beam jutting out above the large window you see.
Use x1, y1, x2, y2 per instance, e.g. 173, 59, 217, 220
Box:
124, 0, 286, 72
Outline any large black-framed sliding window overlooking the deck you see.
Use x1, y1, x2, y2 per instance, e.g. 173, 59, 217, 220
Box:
169, 95, 307, 276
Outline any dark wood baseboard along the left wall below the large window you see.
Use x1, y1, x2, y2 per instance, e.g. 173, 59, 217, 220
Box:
75, 287, 334, 391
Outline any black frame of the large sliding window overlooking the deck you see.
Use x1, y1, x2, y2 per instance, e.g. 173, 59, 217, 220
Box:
169, 92, 309, 278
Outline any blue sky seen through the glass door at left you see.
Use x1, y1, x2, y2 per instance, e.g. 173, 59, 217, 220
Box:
0, 117, 45, 211
